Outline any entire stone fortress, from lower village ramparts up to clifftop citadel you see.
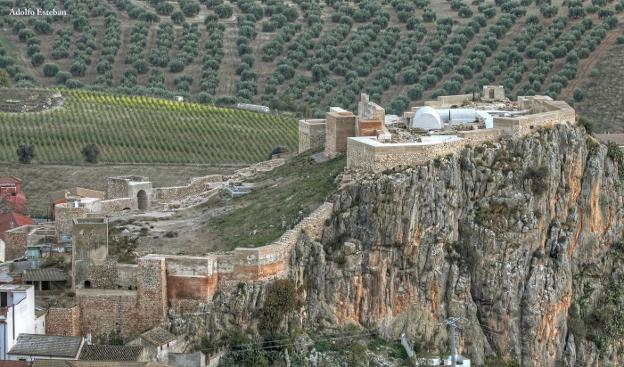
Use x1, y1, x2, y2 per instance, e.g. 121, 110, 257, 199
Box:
7, 86, 576, 344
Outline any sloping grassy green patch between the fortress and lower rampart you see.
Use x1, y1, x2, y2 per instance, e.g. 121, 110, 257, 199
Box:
210, 155, 346, 248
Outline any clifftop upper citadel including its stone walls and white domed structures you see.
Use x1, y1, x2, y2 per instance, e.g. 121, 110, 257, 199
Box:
299, 86, 576, 171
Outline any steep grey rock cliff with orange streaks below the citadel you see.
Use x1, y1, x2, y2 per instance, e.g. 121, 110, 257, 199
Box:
291, 126, 624, 366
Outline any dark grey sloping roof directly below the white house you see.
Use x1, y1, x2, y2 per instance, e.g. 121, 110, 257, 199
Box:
7, 334, 84, 362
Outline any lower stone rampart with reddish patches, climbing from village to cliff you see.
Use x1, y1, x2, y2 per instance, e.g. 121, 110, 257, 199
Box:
47, 203, 333, 338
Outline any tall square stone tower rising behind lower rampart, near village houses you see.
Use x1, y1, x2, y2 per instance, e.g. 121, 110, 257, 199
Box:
72, 218, 111, 289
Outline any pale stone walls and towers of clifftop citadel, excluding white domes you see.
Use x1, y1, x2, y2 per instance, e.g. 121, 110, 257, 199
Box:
299, 90, 576, 171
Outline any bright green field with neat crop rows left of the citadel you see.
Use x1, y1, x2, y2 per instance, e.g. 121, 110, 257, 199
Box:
0, 91, 297, 165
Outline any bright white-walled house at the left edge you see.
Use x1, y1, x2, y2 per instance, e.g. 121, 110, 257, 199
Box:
0, 284, 37, 359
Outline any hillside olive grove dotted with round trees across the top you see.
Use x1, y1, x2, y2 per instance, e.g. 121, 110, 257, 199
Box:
0, 0, 624, 115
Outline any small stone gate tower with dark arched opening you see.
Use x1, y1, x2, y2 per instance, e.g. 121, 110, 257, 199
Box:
106, 176, 153, 210
